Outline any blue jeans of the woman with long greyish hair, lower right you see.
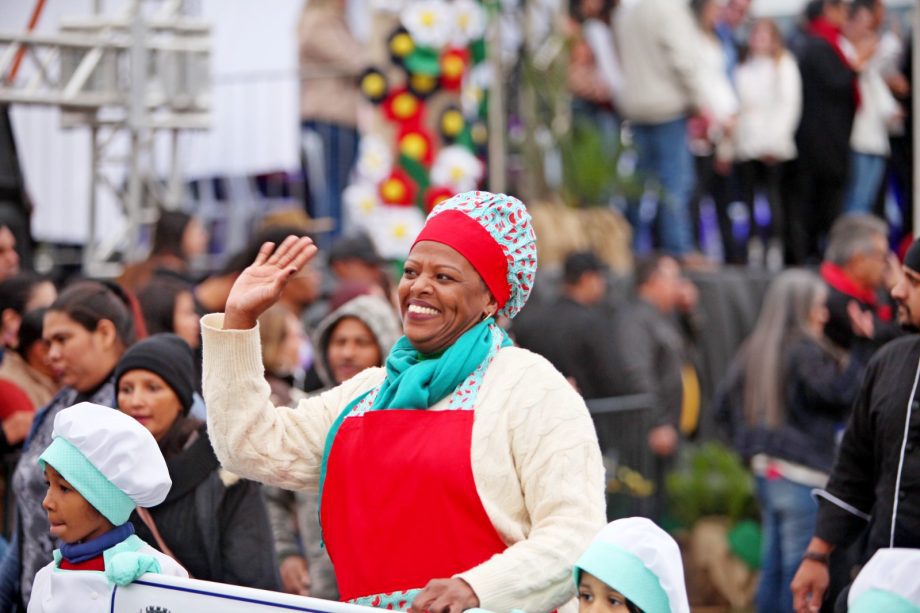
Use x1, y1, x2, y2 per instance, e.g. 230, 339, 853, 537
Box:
756, 477, 818, 613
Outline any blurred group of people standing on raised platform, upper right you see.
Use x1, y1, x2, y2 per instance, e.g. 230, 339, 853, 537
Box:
568, 0, 912, 271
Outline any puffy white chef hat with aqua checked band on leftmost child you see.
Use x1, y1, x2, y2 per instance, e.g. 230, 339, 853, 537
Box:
38, 402, 172, 526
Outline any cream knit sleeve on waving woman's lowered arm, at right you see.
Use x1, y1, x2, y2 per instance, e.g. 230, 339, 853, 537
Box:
458, 349, 606, 613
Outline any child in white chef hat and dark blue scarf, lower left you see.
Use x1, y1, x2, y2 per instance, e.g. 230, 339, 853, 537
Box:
29, 402, 188, 613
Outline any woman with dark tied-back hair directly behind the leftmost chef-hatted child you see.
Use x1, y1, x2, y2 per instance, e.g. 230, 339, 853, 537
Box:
0, 281, 135, 611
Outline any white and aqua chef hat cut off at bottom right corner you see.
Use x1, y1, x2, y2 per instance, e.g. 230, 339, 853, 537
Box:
847, 549, 920, 613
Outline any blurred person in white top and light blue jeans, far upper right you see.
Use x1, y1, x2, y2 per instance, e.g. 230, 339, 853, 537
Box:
843, 2, 903, 214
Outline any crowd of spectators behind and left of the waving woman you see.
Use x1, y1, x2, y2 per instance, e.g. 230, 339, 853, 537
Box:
0, 212, 402, 602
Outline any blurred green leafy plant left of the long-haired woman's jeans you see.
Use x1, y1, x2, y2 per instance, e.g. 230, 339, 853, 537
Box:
666, 441, 757, 528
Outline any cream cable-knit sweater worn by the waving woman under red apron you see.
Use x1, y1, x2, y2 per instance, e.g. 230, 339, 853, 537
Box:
201, 314, 606, 613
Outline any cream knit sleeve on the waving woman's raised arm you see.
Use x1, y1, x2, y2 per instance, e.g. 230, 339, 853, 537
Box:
201, 313, 384, 490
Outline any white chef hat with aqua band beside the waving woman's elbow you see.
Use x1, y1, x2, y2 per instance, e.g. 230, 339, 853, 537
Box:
574, 517, 690, 613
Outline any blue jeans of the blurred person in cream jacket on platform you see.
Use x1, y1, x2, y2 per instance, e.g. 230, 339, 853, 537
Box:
630, 117, 696, 255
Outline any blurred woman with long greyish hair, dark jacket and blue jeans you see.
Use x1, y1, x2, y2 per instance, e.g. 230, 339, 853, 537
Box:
717, 269, 867, 611
